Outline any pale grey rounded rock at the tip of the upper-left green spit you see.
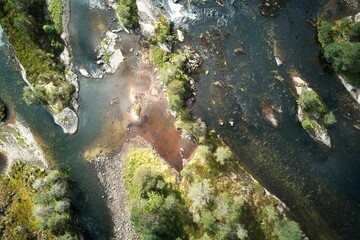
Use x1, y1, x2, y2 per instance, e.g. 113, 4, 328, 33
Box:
53, 108, 79, 134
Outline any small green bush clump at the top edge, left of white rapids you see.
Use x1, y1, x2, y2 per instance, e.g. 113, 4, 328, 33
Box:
116, 0, 139, 29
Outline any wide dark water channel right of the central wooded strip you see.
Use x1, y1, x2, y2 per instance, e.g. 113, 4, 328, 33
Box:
184, 0, 360, 239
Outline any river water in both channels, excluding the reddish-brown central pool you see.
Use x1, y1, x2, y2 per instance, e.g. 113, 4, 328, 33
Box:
0, 0, 360, 239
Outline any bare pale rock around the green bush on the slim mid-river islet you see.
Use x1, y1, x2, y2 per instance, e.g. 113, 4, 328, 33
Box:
292, 77, 331, 148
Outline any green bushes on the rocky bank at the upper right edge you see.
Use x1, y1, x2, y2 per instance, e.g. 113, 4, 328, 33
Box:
318, 18, 360, 87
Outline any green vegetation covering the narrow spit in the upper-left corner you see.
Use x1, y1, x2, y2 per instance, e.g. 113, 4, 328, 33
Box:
0, 0, 75, 113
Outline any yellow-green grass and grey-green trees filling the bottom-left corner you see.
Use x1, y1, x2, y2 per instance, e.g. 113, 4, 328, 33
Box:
0, 161, 77, 240
